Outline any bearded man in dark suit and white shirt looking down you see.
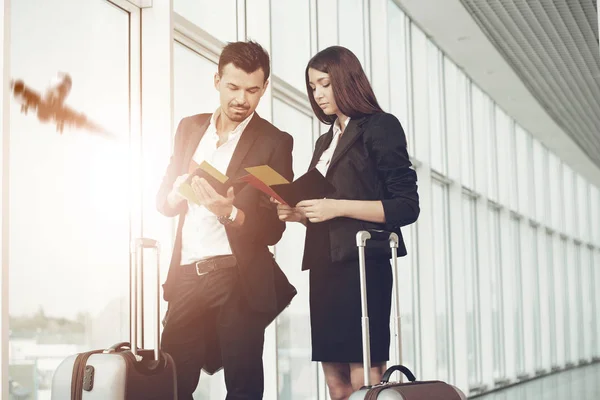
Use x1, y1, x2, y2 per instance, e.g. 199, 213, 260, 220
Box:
157, 42, 296, 400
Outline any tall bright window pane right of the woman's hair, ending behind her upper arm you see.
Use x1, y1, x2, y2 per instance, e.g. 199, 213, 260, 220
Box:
388, 0, 414, 139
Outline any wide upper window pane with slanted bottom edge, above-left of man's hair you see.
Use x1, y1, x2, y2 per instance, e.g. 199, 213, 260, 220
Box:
173, 0, 237, 42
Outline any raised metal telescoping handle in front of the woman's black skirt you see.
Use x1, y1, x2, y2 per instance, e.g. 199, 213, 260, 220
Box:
356, 229, 402, 386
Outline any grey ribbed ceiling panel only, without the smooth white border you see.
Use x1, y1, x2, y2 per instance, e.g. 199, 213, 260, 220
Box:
461, 0, 600, 166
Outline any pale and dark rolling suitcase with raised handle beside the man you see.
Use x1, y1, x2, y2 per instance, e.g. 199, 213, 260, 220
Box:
51, 238, 177, 400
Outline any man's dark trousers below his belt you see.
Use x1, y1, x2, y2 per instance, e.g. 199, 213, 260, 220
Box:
162, 267, 265, 400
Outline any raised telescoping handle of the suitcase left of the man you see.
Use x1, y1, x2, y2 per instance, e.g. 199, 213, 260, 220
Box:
130, 238, 160, 360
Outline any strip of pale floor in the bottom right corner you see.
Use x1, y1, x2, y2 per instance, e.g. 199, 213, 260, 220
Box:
477, 363, 600, 400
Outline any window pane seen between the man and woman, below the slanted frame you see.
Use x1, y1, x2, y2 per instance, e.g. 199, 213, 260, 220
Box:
273, 99, 317, 400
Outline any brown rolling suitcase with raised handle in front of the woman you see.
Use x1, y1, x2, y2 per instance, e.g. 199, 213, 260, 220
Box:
349, 230, 466, 400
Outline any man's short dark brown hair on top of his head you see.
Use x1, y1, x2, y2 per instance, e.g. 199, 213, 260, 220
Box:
219, 41, 271, 82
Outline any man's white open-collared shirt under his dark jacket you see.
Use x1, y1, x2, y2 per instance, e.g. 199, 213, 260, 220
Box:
181, 108, 254, 265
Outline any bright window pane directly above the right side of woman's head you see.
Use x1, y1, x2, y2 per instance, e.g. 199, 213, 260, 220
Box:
338, 0, 367, 66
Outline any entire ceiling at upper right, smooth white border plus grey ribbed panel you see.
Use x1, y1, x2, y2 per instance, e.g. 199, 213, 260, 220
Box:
394, 0, 600, 187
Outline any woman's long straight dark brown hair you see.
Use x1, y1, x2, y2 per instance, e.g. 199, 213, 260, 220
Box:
304, 46, 383, 125
